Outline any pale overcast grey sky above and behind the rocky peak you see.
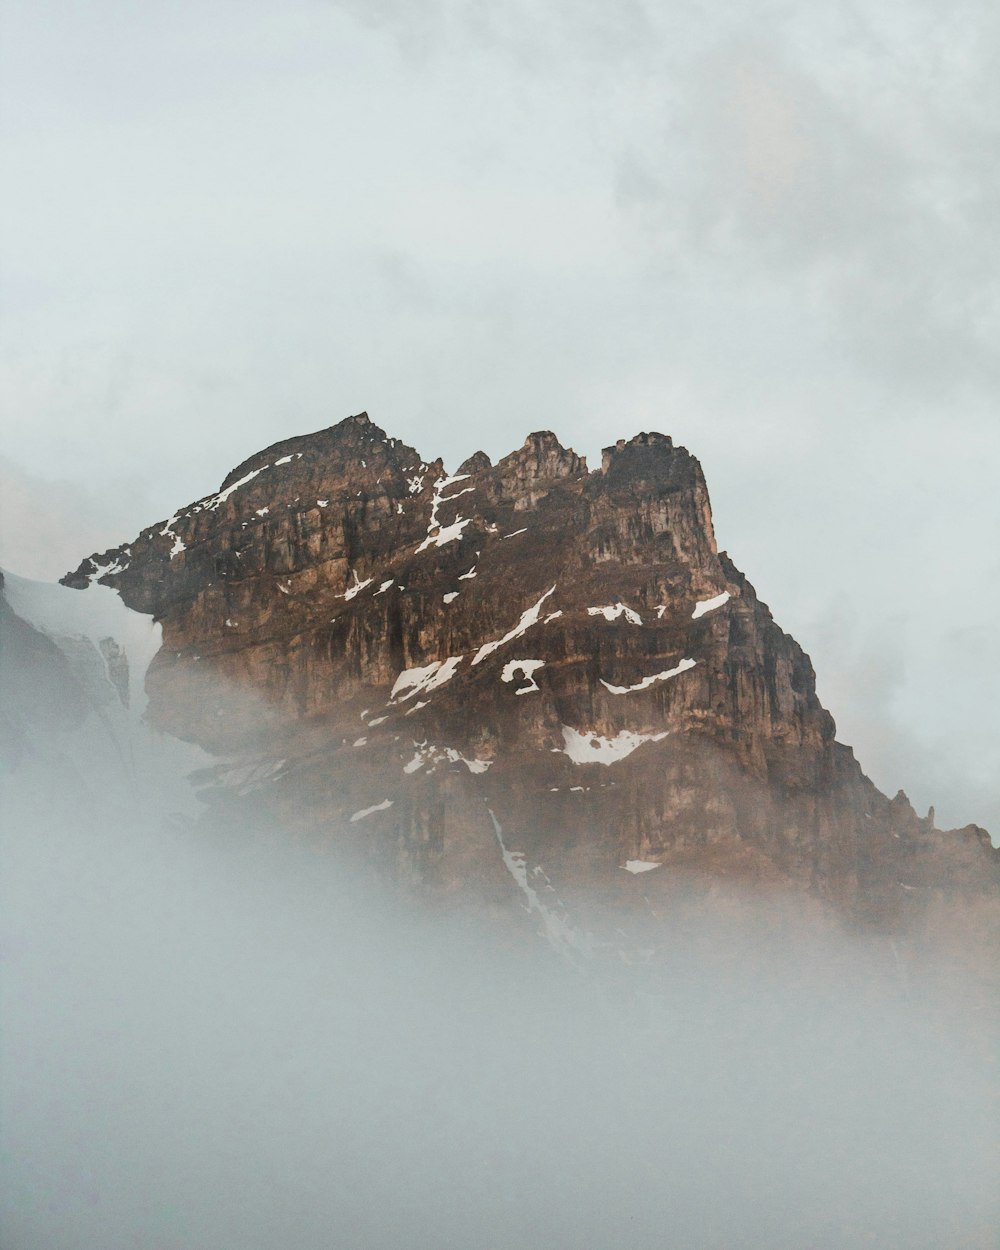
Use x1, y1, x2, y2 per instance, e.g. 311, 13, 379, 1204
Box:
0, 0, 1000, 836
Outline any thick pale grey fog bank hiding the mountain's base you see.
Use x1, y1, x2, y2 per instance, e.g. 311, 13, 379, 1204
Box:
0, 755, 1000, 1250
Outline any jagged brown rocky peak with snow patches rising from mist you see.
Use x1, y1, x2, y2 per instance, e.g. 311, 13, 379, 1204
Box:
64, 414, 998, 929
